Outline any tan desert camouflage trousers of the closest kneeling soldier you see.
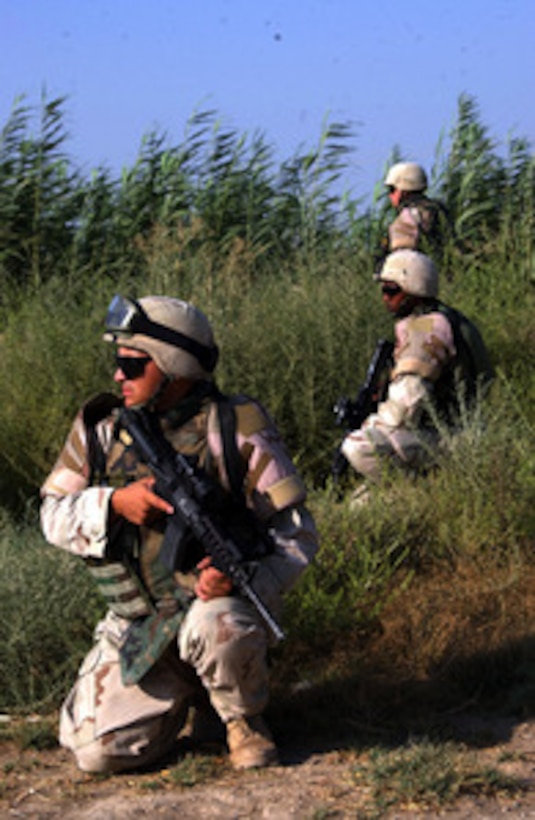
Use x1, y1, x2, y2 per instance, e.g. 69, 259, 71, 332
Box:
59, 597, 268, 772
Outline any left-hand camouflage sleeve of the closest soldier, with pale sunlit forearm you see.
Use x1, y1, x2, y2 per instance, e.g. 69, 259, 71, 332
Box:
41, 413, 113, 558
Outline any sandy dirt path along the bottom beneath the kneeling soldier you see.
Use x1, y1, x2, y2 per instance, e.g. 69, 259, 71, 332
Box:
0, 720, 535, 820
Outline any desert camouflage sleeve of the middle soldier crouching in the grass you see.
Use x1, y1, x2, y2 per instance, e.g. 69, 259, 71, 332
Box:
363, 313, 455, 428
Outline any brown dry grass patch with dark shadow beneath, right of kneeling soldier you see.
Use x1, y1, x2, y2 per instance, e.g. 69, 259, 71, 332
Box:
275, 563, 535, 743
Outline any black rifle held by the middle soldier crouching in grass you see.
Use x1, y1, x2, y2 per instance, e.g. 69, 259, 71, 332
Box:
331, 339, 394, 481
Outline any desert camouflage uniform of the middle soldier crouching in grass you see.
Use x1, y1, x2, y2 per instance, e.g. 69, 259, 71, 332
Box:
342, 308, 475, 482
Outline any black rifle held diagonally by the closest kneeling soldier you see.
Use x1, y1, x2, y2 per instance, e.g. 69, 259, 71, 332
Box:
119, 408, 285, 640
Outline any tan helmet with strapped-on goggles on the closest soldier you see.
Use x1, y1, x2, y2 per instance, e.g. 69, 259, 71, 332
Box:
104, 295, 218, 380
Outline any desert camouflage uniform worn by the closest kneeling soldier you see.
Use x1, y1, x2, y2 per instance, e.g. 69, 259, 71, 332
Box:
41, 390, 317, 771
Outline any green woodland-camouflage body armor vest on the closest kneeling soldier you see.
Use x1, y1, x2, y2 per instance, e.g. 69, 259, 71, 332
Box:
84, 392, 276, 685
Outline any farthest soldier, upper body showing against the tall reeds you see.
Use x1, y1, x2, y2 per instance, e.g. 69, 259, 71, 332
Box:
383, 162, 453, 264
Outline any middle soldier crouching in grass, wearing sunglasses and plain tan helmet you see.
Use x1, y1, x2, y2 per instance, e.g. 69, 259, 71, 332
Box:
341, 249, 493, 500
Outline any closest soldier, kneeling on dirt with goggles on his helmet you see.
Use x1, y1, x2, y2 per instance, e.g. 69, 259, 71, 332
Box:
41, 296, 318, 772
